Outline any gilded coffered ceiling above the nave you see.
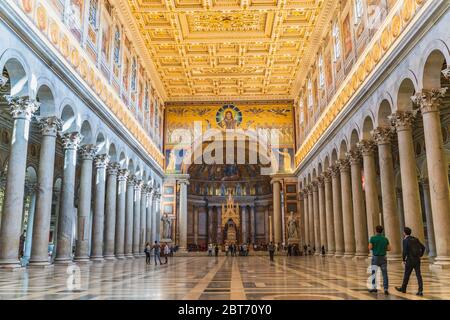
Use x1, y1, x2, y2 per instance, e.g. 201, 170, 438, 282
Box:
128, 0, 337, 101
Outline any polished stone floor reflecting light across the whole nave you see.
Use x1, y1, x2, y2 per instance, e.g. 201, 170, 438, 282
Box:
0, 256, 450, 300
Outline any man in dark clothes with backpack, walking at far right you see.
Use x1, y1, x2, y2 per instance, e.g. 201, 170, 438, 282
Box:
395, 227, 425, 296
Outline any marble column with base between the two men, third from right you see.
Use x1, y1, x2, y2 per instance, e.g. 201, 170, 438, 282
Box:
372, 127, 401, 260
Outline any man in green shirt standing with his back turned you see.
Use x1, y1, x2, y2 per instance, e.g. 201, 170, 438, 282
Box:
369, 226, 391, 295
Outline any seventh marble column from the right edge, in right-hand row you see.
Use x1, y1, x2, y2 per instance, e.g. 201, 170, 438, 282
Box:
332, 165, 344, 258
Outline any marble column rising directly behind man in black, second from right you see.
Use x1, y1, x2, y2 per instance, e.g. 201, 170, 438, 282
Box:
389, 111, 425, 242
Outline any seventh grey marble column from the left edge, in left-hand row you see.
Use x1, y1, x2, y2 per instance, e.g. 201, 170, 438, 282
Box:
114, 169, 128, 259
